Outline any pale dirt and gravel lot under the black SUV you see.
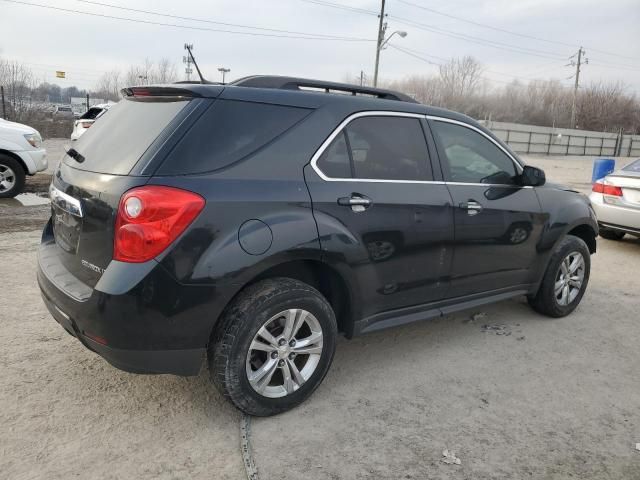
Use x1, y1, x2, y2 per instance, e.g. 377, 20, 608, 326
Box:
0, 147, 640, 480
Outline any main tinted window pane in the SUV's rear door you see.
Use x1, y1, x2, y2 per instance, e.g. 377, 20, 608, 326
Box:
346, 117, 431, 180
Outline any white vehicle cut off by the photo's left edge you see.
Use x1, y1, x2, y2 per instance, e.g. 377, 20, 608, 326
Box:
0, 118, 48, 198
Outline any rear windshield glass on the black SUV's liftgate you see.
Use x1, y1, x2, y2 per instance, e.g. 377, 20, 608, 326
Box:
69, 98, 189, 175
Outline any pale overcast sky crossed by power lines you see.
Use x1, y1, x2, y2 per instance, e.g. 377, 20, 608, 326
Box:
0, 0, 640, 92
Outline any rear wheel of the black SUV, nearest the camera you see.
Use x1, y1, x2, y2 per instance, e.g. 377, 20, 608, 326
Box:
208, 278, 337, 416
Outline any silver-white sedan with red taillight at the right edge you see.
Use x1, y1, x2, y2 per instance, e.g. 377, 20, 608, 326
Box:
589, 159, 640, 240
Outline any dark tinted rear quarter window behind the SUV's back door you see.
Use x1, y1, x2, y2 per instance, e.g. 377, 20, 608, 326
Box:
159, 100, 309, 175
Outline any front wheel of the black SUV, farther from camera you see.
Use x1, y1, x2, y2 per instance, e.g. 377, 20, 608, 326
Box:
528, 235, 591, 318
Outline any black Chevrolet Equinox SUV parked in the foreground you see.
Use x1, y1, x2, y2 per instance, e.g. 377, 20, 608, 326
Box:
38, 76, 598, 415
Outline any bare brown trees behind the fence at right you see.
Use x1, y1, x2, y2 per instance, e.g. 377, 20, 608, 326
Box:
385, 56, 640, 133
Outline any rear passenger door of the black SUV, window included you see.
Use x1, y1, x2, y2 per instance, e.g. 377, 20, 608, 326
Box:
305, 112, 453, 324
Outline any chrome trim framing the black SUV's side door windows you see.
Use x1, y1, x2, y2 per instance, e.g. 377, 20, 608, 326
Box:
310, 110, 533, 188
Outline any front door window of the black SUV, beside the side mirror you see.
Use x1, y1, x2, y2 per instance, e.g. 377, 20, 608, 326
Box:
433, 121, 518, 184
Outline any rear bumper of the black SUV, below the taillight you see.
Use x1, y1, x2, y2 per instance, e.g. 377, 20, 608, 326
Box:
37, 221, 231, 375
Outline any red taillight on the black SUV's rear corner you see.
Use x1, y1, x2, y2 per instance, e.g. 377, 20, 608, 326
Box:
113, 185, 205, 263
